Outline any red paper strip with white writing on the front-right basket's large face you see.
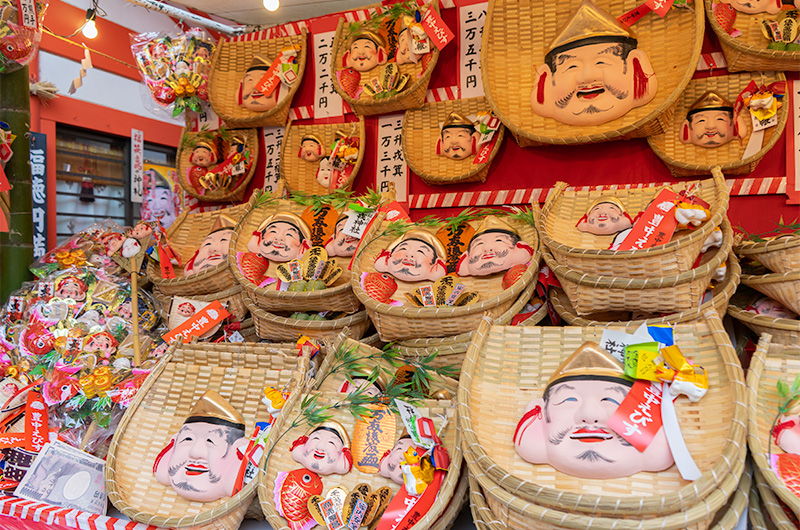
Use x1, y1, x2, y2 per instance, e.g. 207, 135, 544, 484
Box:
608, 379, 661, 451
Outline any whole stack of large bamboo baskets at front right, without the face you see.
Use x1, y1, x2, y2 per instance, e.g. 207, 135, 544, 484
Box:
458, 311, 751, 530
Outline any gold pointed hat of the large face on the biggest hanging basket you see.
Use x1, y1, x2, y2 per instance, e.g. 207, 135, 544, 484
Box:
548, 0, 636, 55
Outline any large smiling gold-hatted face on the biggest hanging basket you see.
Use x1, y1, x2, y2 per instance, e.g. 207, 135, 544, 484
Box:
531, 0, 658, 125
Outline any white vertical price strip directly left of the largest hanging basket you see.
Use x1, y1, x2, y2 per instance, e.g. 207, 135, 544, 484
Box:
458, 2, 489, 98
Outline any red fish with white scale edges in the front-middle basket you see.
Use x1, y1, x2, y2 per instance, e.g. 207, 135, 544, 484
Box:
274, 469, 322, 530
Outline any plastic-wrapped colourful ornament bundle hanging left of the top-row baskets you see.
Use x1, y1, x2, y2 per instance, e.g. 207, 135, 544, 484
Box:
131, 28, 214, 117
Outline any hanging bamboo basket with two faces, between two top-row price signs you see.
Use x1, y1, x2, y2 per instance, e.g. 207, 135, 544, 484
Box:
331, 2, 439, 116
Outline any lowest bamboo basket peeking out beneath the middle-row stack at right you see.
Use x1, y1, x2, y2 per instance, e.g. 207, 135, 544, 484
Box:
550, 254, 742, 326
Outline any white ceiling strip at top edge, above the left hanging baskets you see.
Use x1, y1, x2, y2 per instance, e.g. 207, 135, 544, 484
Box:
165, 0, 376, 26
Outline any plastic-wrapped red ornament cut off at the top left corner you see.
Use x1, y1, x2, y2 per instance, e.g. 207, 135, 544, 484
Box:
0, 0, 48, 74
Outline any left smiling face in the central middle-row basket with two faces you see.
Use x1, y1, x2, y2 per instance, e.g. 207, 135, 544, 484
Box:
375, 230, 447, 282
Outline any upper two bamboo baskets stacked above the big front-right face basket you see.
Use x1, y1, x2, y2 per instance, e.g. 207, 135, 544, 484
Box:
535, 168, 735, 322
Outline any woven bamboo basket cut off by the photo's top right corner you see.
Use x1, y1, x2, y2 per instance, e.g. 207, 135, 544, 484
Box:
705, 0, 800, 72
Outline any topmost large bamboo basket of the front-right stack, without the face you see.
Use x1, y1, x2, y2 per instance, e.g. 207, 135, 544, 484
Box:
459, 311, 746, 516
